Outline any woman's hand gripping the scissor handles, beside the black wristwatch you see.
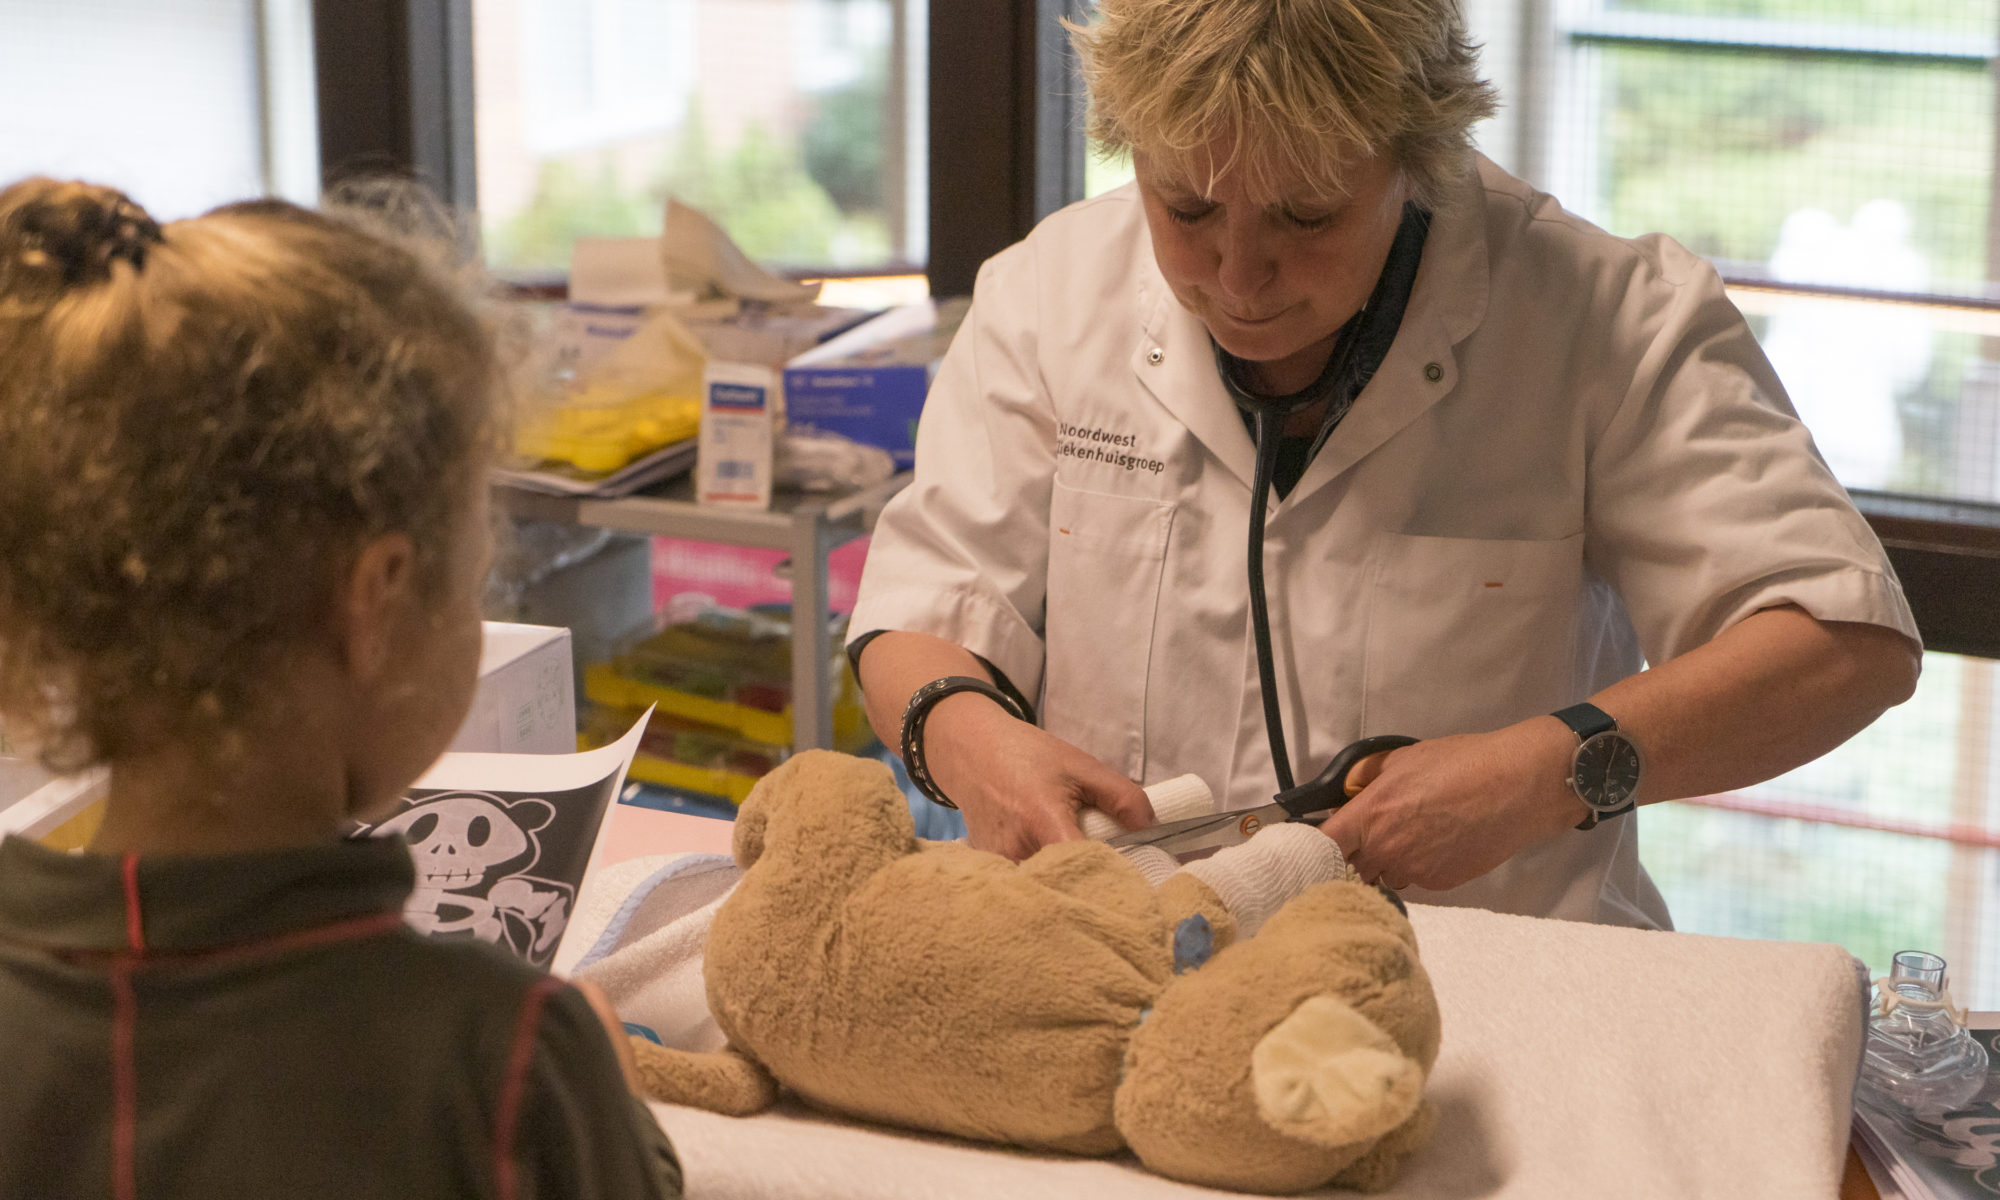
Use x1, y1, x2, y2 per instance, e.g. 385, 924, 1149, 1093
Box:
1320, 716, 1588, 892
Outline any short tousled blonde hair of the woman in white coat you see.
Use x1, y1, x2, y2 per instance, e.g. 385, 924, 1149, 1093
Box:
1070, 0, 1494, 208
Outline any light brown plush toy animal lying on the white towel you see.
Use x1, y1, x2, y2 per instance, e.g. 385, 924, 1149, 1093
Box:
634, 750, 1440, 1194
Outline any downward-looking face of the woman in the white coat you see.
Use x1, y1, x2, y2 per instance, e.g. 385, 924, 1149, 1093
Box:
1134, 142, 1404, 392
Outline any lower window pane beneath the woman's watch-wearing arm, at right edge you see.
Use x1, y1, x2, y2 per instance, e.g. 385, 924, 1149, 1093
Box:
1640, 654, 2000, 1010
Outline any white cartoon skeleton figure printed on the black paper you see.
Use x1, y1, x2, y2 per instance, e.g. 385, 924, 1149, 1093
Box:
374, 792, 572, 958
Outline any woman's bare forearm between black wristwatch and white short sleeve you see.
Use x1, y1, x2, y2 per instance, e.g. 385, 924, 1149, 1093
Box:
1594, 606, 1920, 802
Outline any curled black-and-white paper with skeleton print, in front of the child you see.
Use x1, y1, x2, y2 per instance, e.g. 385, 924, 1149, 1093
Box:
356, 710, 652, 968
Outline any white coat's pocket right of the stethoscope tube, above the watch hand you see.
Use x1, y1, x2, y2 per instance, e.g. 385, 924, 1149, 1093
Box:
1362, 534, 1584, 738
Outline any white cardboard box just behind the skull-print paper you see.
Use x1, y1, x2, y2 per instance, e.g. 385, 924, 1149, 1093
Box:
450, 620, 576, 754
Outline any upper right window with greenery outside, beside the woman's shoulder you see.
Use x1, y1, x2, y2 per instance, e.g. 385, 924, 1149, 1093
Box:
1468, 0, 2000, 500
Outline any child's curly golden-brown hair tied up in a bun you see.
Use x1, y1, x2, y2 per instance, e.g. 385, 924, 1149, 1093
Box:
0, 178, 500, 770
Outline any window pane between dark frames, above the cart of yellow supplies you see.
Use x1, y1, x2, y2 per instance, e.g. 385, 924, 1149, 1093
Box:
474, 0, 926, 270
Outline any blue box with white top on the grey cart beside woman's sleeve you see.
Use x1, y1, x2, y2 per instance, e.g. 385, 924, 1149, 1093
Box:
784, 298, 970, 470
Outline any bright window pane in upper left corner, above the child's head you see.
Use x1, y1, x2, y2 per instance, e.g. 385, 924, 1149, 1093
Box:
0, 0, 318, 220
